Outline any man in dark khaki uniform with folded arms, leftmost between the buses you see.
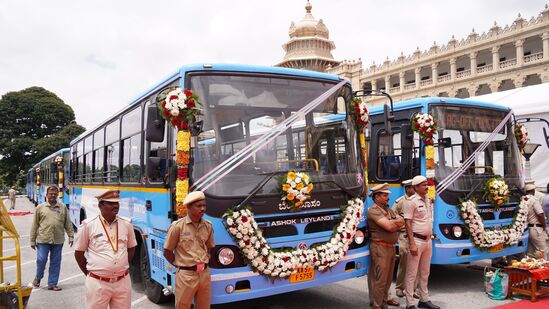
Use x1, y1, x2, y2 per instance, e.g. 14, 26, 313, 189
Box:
366, 183, 404, 308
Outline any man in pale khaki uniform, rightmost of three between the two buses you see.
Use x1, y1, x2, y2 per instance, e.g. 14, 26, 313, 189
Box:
404, 175, 440, 309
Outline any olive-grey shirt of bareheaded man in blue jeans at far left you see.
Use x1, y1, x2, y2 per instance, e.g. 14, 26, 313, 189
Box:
30, 202, 74, 246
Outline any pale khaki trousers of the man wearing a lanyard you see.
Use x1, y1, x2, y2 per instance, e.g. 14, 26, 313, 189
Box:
86, 275, 132, 309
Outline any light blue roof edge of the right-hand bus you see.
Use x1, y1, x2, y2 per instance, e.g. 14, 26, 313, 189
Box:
369, 97, 510, 115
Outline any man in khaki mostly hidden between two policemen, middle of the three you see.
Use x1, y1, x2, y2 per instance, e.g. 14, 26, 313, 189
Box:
392, 179, 416, 297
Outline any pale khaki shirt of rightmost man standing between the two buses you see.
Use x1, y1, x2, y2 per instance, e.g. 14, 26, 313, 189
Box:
403, 193, 434, 236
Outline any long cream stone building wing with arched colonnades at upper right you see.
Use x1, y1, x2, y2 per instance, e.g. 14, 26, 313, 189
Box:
326, 5, 549, 104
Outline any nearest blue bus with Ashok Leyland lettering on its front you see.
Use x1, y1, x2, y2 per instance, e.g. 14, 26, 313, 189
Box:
70, 64, 369, 304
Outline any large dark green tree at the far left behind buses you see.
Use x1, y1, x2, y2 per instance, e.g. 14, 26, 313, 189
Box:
0, 87, 85, 185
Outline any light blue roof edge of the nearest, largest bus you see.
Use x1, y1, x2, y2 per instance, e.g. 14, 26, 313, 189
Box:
70, 63, 342, 146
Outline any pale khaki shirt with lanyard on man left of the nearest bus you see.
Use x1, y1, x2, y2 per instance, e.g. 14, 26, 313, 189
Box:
74, 215, 137, 278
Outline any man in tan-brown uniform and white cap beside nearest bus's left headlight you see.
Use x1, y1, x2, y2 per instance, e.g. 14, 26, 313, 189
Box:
164, 191, 215, 309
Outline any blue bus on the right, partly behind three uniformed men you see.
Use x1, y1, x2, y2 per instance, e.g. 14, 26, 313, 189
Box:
368, 98, 528, 264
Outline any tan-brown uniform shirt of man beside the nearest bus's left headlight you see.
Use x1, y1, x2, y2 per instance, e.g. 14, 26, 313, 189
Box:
164, 215, 215, 267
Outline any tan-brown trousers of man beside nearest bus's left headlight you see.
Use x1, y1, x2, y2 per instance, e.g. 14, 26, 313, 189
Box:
174, 268, 211, 309
